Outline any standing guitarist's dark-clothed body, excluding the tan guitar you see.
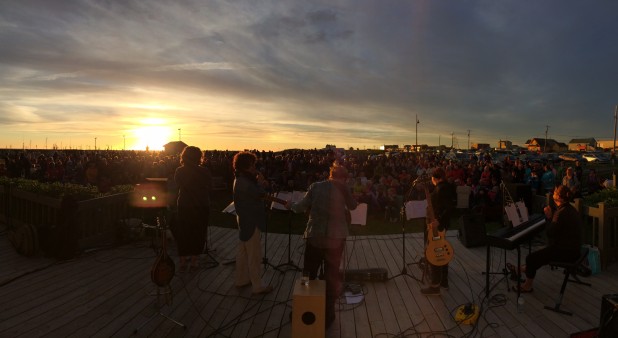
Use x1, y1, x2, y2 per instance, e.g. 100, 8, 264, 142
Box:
421, 167, 457, 295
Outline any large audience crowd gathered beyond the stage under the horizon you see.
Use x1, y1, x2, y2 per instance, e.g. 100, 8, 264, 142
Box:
0, 149, 603, 221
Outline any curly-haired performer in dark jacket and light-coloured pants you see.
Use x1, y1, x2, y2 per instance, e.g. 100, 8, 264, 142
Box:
232, 152, 273, 294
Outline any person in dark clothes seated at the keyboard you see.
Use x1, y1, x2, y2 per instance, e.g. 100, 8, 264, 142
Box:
508, 185, 582, 292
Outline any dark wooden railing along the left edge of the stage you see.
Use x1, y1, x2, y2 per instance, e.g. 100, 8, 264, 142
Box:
0, 185, 130, 256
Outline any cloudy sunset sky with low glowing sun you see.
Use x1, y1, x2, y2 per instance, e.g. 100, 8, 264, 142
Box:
0, 0, 618, 151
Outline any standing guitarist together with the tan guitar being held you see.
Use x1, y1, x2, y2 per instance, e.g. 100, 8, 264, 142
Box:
421, 167, 457, 295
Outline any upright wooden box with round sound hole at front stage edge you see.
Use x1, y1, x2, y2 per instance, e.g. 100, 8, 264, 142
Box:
292, 280, 326, 338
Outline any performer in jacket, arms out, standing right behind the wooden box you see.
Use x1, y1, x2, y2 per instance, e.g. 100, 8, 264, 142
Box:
286, 164, 357, 328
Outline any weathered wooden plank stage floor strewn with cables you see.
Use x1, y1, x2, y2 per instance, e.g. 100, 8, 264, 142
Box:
0, 223, 618, 338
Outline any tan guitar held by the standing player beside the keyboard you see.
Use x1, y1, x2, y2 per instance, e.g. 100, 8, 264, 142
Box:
423, 184, 455, 266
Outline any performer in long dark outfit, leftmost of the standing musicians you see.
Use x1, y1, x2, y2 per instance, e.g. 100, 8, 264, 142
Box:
174, 146, 212, 272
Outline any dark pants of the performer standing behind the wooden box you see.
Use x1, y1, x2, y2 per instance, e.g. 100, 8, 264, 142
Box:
303, 239, 345, 321
